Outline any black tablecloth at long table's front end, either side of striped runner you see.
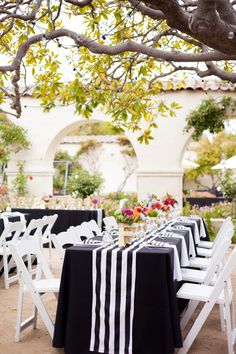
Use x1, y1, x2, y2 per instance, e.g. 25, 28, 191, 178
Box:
53, 239, 182, 354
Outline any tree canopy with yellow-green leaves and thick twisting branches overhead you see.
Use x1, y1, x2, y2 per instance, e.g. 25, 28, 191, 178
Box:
0, 0, 236, 142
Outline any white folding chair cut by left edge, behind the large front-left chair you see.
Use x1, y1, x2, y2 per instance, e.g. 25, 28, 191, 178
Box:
0, 221, 25, 289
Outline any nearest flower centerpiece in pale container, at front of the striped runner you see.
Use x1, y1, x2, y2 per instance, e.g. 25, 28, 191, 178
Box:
114, 208, 145, 247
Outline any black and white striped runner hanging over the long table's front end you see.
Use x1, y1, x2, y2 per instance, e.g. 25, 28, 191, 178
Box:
90, 239, 143, 354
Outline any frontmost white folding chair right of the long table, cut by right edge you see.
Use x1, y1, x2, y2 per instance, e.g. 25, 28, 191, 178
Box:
177, 249, 236, 354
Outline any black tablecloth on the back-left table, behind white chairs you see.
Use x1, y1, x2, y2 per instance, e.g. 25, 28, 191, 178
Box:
12, 208, 105, 234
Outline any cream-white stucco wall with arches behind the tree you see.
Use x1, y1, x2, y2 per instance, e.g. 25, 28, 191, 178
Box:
4, 90, 236, 203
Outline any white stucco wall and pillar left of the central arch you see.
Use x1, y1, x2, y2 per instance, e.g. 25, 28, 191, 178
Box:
6, 97, 141, 196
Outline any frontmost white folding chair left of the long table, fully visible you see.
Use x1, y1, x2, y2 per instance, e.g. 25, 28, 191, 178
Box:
9, 238, 60, 342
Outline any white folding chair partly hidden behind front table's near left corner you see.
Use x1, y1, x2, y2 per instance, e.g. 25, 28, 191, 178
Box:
51, 229, 79, 261
